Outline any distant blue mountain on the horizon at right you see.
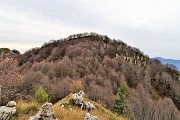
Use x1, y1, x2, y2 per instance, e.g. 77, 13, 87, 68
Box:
155, 57, 180, 70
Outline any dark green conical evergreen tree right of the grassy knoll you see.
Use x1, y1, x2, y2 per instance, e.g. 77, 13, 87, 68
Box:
112, 82, 130, 117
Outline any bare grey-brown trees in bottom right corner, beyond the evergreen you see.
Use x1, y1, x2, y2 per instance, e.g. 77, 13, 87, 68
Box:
130, 85, 180, 120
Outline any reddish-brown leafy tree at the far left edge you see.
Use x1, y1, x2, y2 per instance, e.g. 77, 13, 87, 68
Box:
0, 58, 23, 104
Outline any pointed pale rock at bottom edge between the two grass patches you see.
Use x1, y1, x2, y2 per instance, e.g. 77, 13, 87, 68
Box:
29, 102, 56, 120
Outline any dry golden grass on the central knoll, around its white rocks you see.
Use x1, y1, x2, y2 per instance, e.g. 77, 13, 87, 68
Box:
54, 94, 127, 120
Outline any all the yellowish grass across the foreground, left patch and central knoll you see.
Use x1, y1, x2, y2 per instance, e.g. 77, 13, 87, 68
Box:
12, 94, 126, 120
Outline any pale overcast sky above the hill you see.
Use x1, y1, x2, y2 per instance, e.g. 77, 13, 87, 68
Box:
0, 0, 180, 59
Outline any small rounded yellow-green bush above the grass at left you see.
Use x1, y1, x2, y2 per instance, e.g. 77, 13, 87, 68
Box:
34, 87, 49, 103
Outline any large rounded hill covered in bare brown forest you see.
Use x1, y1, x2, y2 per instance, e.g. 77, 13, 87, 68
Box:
8, 33, 180, 120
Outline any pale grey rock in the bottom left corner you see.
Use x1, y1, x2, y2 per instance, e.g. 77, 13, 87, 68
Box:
0, 101, 16, 120
